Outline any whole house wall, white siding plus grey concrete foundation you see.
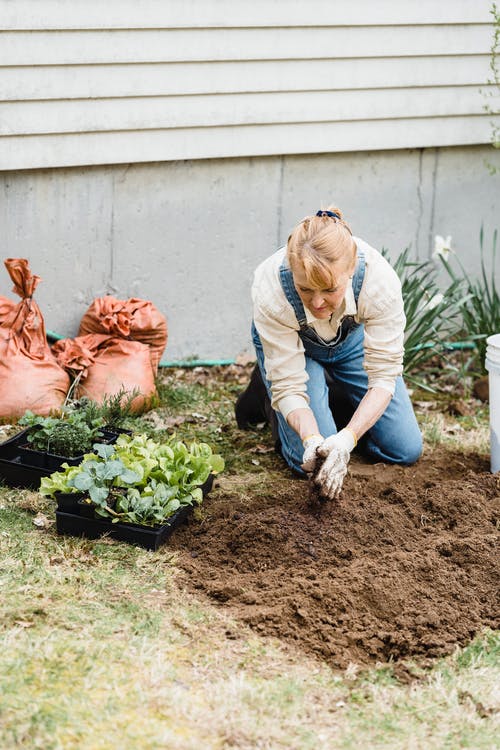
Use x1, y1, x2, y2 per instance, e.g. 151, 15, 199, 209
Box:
0, 0, 500, 359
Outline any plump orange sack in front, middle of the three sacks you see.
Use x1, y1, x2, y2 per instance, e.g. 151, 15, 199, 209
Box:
52, 333, 156, 412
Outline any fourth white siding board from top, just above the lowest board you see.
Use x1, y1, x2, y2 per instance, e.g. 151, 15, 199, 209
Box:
0, 86, 494, 135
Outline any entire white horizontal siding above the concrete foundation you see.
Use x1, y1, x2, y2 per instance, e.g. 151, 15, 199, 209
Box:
0, 0, 493, 169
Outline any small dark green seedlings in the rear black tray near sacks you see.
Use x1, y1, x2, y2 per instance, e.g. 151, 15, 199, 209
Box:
19, 409, 103, 458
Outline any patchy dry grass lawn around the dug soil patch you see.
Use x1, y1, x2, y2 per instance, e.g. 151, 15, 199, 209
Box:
0, 366, 500, 750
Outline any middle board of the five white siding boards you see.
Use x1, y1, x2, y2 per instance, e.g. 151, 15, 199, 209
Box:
0, 55, 490, 101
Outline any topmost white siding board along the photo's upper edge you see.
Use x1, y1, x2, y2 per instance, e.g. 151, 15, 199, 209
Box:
0, 0, 490, 30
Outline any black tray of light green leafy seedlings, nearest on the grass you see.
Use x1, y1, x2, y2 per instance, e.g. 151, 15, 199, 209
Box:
40, 435, 224, 549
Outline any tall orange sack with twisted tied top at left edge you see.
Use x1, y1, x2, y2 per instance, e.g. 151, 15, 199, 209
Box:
0, 258, 70, 420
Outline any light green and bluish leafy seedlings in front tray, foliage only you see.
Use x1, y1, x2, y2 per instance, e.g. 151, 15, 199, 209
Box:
40, 435, 224, 526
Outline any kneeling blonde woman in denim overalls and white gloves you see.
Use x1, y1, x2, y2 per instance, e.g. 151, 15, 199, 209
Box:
246, 207, 422, 499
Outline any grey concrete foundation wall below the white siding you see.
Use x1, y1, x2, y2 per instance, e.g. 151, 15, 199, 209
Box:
0, 146, 500, 360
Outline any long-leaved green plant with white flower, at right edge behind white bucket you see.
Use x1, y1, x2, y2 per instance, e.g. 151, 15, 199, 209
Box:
438, 227, 500, 372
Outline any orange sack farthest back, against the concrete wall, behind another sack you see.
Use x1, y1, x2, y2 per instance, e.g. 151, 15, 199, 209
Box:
78, 295, 168, 375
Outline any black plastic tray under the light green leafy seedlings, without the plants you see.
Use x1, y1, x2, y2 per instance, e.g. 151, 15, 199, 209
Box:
56, 506, 189, 550
